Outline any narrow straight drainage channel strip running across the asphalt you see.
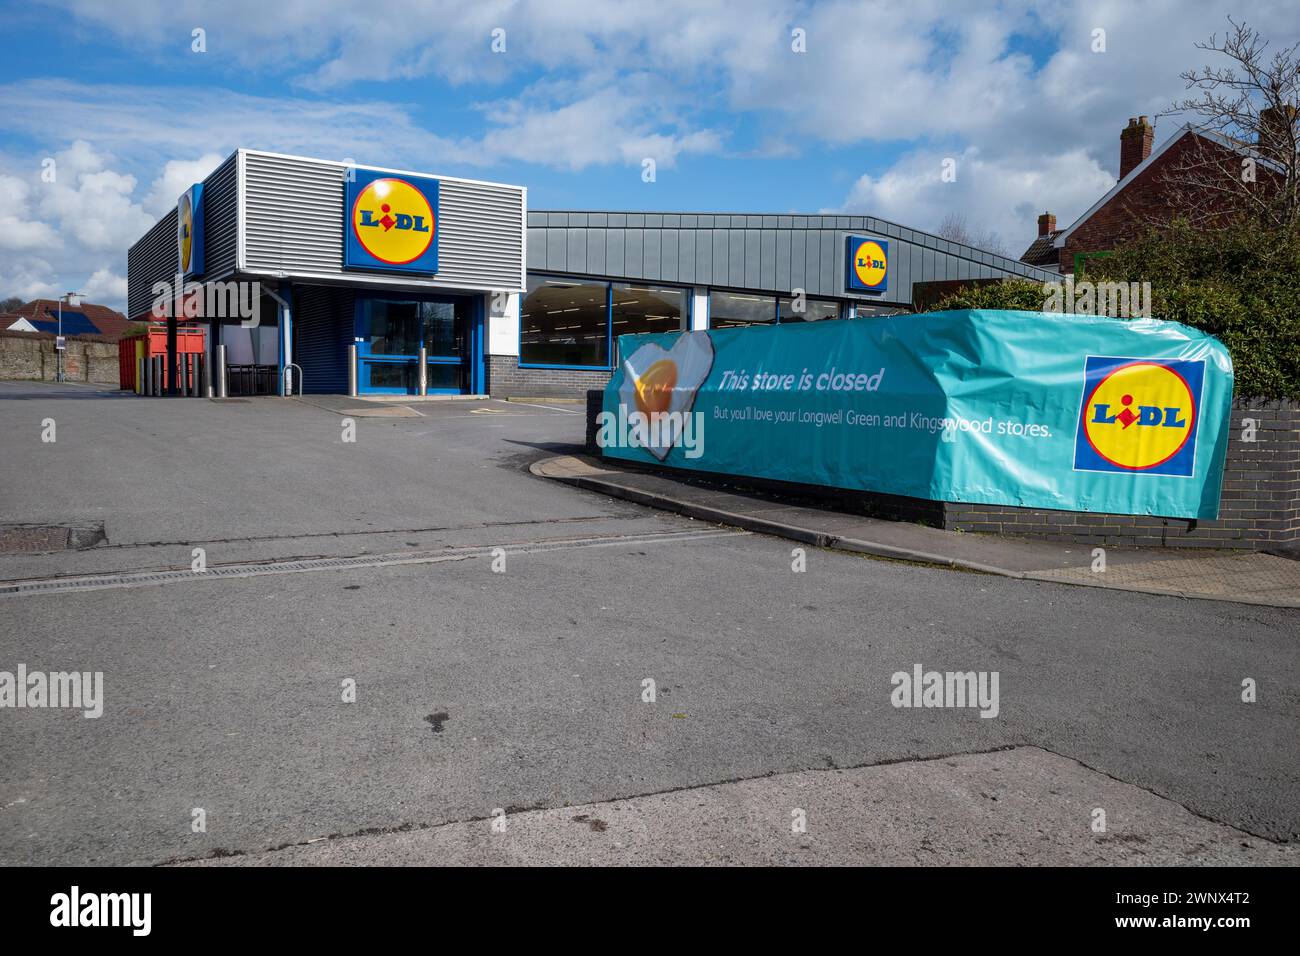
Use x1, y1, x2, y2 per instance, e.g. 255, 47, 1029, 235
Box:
0, 528, 750, 597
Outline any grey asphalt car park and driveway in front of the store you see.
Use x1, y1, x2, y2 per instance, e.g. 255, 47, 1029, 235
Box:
0, 382, 1300, 864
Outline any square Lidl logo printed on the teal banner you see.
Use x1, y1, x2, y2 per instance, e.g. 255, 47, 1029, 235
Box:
1074, 355, 1205, 477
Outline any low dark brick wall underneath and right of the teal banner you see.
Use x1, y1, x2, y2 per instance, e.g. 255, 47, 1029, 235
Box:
586, 390, 1300, 550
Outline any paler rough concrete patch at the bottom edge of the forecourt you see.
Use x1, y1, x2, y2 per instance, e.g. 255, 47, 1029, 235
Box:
189, 747, 1300, 866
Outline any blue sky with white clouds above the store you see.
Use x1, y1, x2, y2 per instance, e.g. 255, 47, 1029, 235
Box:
0, 0, 1300, 306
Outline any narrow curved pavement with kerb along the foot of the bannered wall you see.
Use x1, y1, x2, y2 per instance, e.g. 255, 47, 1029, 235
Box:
532, 454, 1300, 607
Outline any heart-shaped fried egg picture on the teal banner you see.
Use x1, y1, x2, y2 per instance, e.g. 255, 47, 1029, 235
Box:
619, 332, 714, 462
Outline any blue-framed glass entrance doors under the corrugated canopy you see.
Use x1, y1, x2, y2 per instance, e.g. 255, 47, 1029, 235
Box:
356, 298, 472, 395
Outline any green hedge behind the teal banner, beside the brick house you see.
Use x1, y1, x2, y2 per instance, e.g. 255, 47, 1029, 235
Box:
930, 224, 1300, 398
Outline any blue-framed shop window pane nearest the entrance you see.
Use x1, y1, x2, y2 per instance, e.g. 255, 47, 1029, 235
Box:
519, 276, 610, 368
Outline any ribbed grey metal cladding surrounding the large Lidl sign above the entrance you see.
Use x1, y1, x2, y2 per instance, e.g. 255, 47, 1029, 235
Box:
242, 151, 524, 291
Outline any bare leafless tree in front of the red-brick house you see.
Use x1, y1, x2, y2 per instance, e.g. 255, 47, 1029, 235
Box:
1166, 17, 1300, 228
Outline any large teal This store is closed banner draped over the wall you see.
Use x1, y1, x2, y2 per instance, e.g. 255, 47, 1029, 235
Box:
597, 310, 1232, 519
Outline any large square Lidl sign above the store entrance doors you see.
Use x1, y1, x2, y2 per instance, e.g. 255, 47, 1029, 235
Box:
343, 169, 438, 273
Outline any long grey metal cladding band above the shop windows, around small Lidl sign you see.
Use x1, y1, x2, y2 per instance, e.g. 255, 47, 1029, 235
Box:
528, 211, 1060, 304
